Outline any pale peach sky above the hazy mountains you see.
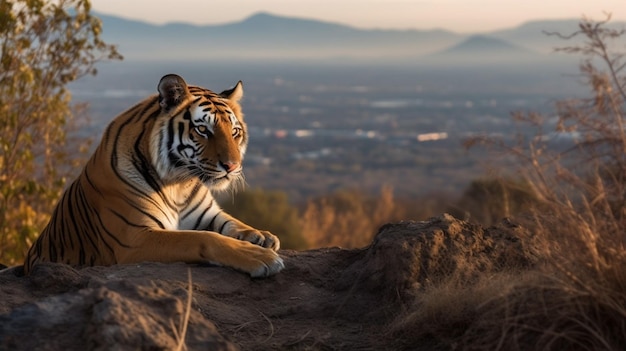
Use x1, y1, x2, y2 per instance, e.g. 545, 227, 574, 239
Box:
91, 0, 626, 33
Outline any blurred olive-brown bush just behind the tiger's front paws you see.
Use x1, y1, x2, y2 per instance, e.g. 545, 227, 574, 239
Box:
221, 189, 306, 250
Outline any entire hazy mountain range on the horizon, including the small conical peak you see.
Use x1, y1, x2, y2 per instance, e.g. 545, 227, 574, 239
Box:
96, 13, 624, 64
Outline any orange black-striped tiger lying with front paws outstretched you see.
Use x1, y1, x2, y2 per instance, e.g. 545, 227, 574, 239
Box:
23, 74, 284, 278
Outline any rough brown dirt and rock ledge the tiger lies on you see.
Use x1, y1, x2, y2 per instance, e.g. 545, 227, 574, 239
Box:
0, 215, 536, 350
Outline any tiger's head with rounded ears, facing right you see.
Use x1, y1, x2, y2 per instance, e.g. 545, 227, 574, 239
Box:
150, 74, 248, 190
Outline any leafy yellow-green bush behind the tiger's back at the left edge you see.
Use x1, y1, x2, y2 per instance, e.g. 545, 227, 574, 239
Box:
0, 0, 121, 264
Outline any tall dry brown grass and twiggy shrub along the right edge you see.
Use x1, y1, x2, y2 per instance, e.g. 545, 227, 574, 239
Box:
391, 16, 626, 350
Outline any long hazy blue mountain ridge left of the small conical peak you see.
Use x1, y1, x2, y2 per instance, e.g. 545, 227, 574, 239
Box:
97, 13, 462, 61
